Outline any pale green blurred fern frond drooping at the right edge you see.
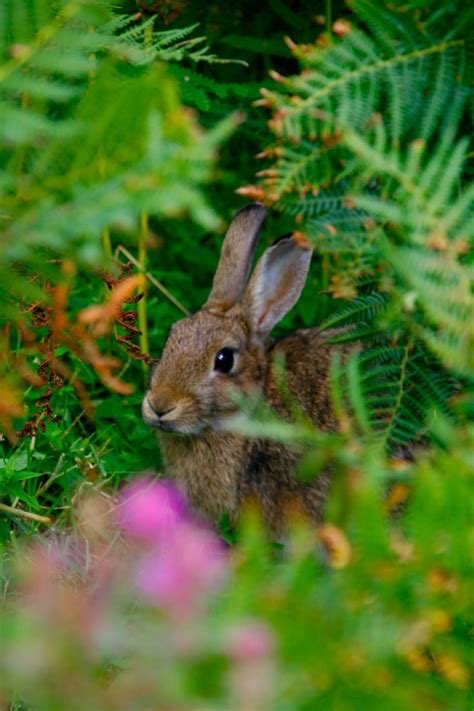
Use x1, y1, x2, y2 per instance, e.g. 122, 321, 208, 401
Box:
346, 124, 474, 375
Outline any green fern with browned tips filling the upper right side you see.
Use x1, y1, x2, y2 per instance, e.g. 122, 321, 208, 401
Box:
260, 0, 474, 449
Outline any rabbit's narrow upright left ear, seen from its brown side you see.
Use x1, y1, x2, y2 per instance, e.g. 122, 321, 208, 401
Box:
205, 202, 267, 311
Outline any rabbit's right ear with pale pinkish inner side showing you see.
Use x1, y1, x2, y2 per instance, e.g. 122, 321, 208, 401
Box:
242, 235, 312, 336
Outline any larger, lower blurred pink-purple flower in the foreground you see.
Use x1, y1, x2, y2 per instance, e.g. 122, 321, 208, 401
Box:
137, 522, 226, 618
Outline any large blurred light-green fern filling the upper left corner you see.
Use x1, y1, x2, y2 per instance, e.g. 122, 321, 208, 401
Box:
0, 0, 234, 313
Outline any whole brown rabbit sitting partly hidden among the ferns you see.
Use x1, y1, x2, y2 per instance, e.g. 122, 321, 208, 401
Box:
143, 203, 342, 537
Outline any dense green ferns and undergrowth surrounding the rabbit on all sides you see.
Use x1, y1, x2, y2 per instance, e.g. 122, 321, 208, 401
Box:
0, 0, 474, 711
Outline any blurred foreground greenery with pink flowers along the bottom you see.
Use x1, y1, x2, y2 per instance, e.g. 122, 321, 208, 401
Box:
0, 440, 472, 711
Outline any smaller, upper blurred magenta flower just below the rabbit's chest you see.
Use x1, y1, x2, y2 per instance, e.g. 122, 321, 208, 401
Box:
117, 478, 186, 542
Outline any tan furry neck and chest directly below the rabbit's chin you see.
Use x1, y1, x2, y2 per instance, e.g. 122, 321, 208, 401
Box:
158, 430, 247, 521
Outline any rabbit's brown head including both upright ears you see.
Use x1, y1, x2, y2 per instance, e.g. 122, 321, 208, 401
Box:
143, 203, 311, 434
